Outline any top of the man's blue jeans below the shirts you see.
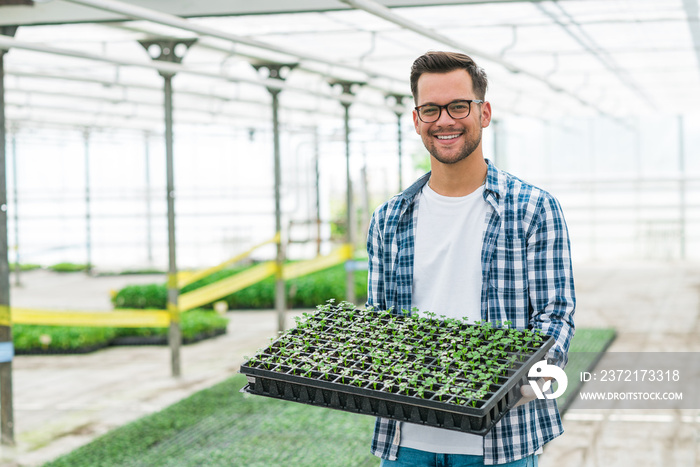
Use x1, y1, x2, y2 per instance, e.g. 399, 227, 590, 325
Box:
381, 447, 537, 467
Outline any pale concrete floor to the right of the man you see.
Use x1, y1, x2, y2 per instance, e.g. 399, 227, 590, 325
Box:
539, 263, 700, 467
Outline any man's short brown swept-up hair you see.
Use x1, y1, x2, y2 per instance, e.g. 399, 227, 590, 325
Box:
411, 52, 488, 104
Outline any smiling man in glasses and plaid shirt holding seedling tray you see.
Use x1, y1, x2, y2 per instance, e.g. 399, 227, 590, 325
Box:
367, 52, 575, 467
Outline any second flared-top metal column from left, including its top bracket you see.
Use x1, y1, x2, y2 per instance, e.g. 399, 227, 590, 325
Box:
253, 62, 296, 331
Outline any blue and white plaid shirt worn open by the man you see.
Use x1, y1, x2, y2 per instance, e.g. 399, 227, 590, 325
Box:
367, 160, 576, 464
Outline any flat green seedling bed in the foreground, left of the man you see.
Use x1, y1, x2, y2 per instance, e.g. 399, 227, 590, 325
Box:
44, 375, 379, 467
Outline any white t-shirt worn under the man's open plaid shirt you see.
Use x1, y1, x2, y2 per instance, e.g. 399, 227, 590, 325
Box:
400, 184, 488, 456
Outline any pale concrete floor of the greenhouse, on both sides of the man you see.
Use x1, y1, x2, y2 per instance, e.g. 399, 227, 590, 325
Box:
0, 263, 700, 467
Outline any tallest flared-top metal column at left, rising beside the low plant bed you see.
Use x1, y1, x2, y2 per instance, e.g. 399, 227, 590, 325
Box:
139, 39, 197, 377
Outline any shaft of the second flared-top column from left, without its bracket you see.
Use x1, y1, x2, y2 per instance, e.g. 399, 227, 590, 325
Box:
268, 88, 287, 331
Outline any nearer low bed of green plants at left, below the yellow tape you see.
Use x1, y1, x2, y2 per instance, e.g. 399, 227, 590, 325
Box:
12, 310, 228, 355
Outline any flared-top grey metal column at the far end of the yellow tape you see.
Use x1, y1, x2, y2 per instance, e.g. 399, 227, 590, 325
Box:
330, 80, 365, 303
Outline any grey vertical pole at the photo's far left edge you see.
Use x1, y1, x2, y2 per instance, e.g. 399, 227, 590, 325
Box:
0, 35, 16, 446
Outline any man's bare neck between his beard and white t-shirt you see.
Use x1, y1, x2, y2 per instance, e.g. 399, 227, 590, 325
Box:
430, 152, 488, 196
